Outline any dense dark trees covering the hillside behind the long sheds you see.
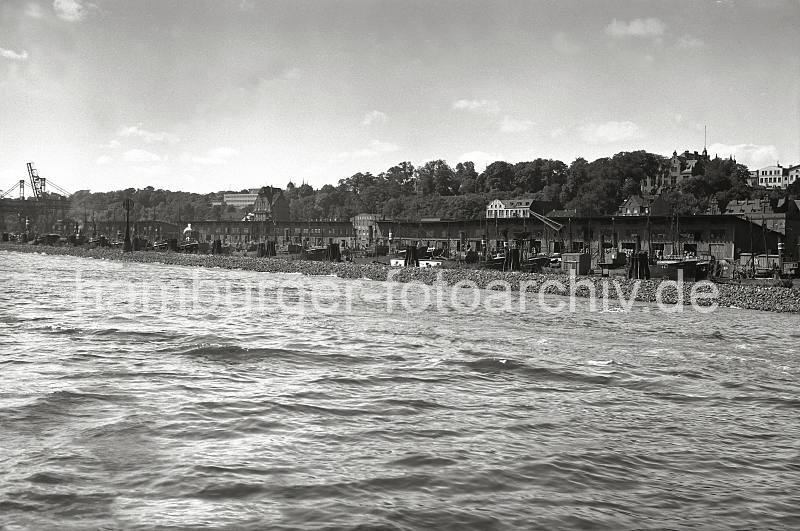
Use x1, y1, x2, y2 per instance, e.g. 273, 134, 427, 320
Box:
71, 151, 776, 223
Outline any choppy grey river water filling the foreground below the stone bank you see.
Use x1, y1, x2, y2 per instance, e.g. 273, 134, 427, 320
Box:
0, 252, 800, 529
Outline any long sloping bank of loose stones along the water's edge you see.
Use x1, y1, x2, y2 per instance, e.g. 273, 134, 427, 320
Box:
0, 244, 800, 313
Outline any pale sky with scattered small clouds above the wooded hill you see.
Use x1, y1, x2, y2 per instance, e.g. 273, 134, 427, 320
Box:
0, 0, 800, 192
